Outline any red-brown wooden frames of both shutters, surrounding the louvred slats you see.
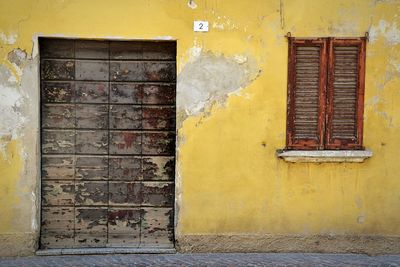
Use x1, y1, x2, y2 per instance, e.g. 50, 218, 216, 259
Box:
286, 37, 366, 153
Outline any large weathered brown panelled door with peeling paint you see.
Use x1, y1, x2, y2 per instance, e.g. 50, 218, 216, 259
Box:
40, 38, 176, 249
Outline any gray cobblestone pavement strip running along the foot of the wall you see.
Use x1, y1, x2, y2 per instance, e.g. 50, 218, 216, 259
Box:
0, 253, 400, 267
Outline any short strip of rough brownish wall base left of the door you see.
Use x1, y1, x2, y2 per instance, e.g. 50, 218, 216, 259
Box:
0, 233, 38, 257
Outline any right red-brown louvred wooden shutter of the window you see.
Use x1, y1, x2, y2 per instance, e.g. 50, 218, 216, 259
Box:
326, 38, 365, 149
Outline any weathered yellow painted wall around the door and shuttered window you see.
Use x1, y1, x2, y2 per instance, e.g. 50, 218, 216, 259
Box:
0, 0, 400, 255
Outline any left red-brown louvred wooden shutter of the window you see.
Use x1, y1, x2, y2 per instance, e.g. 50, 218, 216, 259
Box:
286, 38, 326, 149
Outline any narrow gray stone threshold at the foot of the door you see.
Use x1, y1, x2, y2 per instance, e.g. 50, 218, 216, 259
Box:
36, 248, 176, 256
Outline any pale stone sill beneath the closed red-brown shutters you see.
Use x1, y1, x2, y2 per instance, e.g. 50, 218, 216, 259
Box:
276, 150, 372, 163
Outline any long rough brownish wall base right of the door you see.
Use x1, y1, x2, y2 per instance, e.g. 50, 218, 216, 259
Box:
176, 235, 400, 255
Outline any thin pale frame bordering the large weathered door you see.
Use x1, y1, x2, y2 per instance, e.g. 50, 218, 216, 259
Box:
34, 34, 181, 255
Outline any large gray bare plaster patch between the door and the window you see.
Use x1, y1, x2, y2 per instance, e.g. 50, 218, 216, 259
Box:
177, 52, 258, 115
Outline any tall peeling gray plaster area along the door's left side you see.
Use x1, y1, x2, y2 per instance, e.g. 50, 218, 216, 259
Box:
0, 46, 40, 255
